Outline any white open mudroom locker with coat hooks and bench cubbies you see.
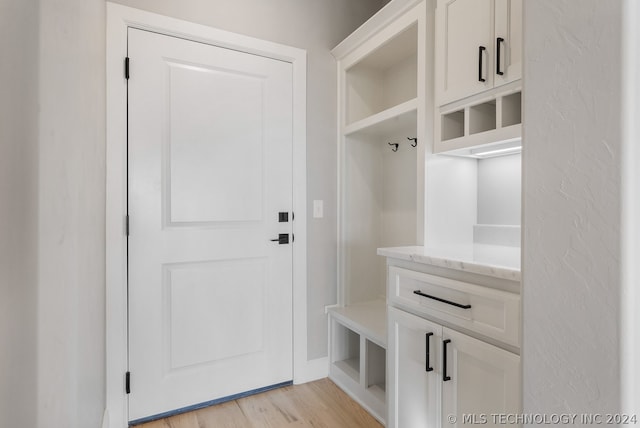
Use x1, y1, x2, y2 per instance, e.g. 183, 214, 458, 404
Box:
329, 1, 427, 422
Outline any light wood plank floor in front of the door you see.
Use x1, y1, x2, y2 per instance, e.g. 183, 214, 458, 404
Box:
136, 379, 382, 428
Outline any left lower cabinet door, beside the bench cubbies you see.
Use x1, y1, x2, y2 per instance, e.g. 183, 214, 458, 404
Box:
387, 307, 442, 428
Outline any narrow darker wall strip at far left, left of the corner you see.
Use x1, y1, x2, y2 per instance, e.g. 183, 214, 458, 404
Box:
0, 0, 38, 428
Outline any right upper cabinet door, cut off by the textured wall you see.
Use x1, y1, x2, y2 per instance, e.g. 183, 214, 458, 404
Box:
494, 0, 522, 86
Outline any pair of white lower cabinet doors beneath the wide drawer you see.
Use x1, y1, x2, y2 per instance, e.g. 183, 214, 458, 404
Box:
387, 307, 521, 428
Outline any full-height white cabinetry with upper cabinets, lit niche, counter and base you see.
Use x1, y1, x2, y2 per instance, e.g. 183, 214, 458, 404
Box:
379, 0, 522, 422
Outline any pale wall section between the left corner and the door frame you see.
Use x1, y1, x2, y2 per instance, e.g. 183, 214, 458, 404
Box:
37, 0, 106, 428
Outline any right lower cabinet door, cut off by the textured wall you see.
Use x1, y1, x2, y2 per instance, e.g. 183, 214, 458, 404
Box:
442, 328, 521, 427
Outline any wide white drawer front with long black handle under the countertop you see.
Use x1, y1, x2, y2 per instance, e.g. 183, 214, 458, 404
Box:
388, 266, 520, 347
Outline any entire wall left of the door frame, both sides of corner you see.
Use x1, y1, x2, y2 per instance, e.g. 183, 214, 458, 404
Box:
0, 0, 105, 428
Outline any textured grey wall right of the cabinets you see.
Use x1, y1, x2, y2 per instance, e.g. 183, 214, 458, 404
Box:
522, 0, 624, 414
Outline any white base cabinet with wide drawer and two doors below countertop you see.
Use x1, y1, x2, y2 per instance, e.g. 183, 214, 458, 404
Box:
383, 258, 521, 428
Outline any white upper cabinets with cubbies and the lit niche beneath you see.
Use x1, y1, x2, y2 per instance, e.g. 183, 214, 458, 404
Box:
424, 0, 522, 247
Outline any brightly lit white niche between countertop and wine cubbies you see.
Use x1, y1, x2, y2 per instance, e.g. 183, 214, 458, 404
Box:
425, 153, 522, 247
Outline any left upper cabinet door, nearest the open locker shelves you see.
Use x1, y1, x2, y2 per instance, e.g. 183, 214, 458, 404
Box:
435, 0, 495, 105
